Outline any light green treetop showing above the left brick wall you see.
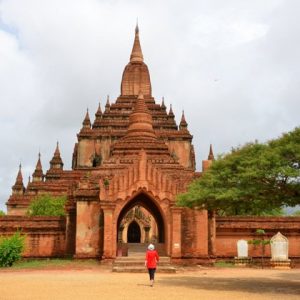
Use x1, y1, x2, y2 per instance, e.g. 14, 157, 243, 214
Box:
27, 194, 66, 216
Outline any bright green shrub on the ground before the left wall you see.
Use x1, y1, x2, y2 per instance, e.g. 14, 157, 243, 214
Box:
0, 232, 25, 267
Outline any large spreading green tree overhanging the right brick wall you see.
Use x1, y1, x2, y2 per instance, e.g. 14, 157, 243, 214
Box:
177, 128, 300, 215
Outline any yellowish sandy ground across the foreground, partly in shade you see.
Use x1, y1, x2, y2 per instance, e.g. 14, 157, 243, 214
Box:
0, 268, 300, 300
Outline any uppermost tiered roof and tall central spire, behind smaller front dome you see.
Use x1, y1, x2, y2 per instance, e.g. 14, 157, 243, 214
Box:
78, 26, 192, 140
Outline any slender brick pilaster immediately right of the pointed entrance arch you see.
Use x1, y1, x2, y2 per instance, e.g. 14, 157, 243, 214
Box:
171, 207, 182, 258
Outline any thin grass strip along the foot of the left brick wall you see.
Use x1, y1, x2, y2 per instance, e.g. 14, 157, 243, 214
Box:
7, 258, 99, 269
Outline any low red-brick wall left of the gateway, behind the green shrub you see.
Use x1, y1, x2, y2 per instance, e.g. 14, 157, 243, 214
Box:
0, 216, 66, 257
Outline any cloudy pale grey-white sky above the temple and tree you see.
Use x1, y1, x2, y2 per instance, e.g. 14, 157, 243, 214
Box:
0, 0, 300, 210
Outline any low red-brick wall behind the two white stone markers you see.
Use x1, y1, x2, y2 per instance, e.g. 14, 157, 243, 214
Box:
215, 217, 300, 258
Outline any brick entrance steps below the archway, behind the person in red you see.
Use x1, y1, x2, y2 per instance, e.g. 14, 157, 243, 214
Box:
112, 243, 176, 273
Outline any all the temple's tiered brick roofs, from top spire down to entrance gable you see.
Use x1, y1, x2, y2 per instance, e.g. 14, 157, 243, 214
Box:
8, 27, 195, 213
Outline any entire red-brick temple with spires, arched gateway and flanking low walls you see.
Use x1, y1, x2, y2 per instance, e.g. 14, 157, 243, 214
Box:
0, 27, 300, 260
